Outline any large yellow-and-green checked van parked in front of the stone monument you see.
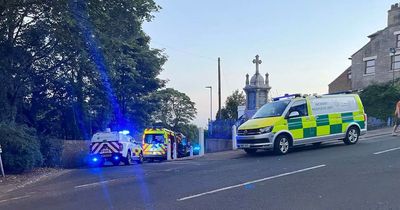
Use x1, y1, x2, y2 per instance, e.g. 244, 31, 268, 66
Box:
236, 94, 367, 154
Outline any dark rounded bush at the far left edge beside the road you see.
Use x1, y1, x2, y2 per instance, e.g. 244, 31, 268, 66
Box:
0, 123, 42, 173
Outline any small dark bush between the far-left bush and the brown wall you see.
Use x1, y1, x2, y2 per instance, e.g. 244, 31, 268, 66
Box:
40, 137, 63, 167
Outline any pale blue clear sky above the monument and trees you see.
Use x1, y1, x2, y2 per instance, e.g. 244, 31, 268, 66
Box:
143, 0, 396, 127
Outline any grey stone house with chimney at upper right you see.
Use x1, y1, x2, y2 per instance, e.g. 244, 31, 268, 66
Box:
329, 4, 400, 93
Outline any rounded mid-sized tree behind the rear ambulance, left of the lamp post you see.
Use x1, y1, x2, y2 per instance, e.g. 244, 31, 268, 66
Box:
153, 88, 197, 130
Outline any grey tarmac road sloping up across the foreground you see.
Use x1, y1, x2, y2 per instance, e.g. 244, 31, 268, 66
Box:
0, 136, 400, 210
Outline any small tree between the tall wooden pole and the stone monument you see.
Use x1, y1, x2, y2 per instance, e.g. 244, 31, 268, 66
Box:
217, 90, 246, 120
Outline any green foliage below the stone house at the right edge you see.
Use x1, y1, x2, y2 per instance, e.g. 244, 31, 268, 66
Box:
360, 82, 400, 120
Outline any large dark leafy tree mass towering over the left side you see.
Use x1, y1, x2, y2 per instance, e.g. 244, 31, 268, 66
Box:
0, 0, 166, 139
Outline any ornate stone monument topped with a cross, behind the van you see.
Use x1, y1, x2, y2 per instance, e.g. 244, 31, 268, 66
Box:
243, 55, 271, 118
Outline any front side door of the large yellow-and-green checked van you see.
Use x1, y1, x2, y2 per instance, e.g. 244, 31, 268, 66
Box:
287, 99, 317, 140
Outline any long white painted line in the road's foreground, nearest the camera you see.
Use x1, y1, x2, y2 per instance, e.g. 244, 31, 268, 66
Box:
177, 165, 326, 201
